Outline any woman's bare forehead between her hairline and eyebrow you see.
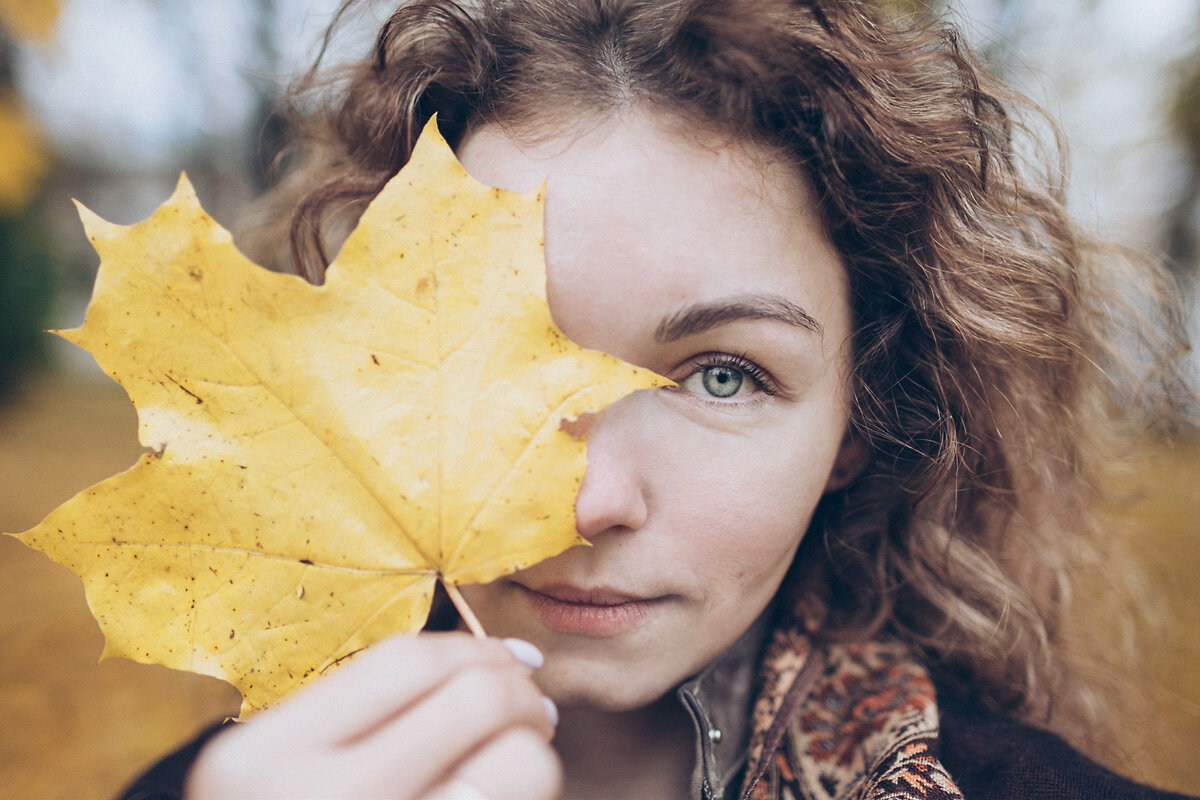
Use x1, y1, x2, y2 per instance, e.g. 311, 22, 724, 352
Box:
458, 113, 848, 359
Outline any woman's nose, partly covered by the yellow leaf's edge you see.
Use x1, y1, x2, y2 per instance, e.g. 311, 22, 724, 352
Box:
575, 397, 647, 540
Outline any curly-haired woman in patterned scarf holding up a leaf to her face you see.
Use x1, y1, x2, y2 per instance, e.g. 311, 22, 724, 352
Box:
119, 0, 1180, 798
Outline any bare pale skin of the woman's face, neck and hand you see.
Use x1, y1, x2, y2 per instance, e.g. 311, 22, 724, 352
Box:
190, 109, 854, 798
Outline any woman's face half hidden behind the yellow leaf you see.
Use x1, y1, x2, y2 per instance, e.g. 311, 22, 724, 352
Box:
458, 113, 851, 710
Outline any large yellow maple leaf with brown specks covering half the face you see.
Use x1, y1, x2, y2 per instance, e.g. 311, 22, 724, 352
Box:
9, 118, 670, 712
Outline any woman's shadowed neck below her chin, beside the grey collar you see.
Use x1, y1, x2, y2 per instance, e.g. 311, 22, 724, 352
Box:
554, 692, 696, 800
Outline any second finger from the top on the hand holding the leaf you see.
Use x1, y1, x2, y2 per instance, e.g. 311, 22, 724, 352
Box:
345, 666, 553, 790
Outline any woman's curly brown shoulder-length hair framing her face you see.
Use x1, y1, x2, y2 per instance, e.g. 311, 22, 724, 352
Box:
243, 0, 1184, 758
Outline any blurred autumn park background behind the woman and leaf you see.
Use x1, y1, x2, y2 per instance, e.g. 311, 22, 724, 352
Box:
0, 0, 1200, 800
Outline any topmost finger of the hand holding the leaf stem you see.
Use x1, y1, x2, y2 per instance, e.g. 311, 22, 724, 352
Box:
262, 633, 515, 746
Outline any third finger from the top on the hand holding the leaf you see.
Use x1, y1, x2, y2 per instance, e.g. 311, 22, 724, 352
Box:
444, 728, 563, 800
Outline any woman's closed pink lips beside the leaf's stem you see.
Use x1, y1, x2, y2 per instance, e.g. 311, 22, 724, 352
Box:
515, 583, 667, 637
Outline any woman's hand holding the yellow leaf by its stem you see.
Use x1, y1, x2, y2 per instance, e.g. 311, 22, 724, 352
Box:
186, 633, 560, 800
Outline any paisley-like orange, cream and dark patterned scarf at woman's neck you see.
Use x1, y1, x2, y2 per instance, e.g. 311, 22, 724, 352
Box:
742, 609, 962, 800
